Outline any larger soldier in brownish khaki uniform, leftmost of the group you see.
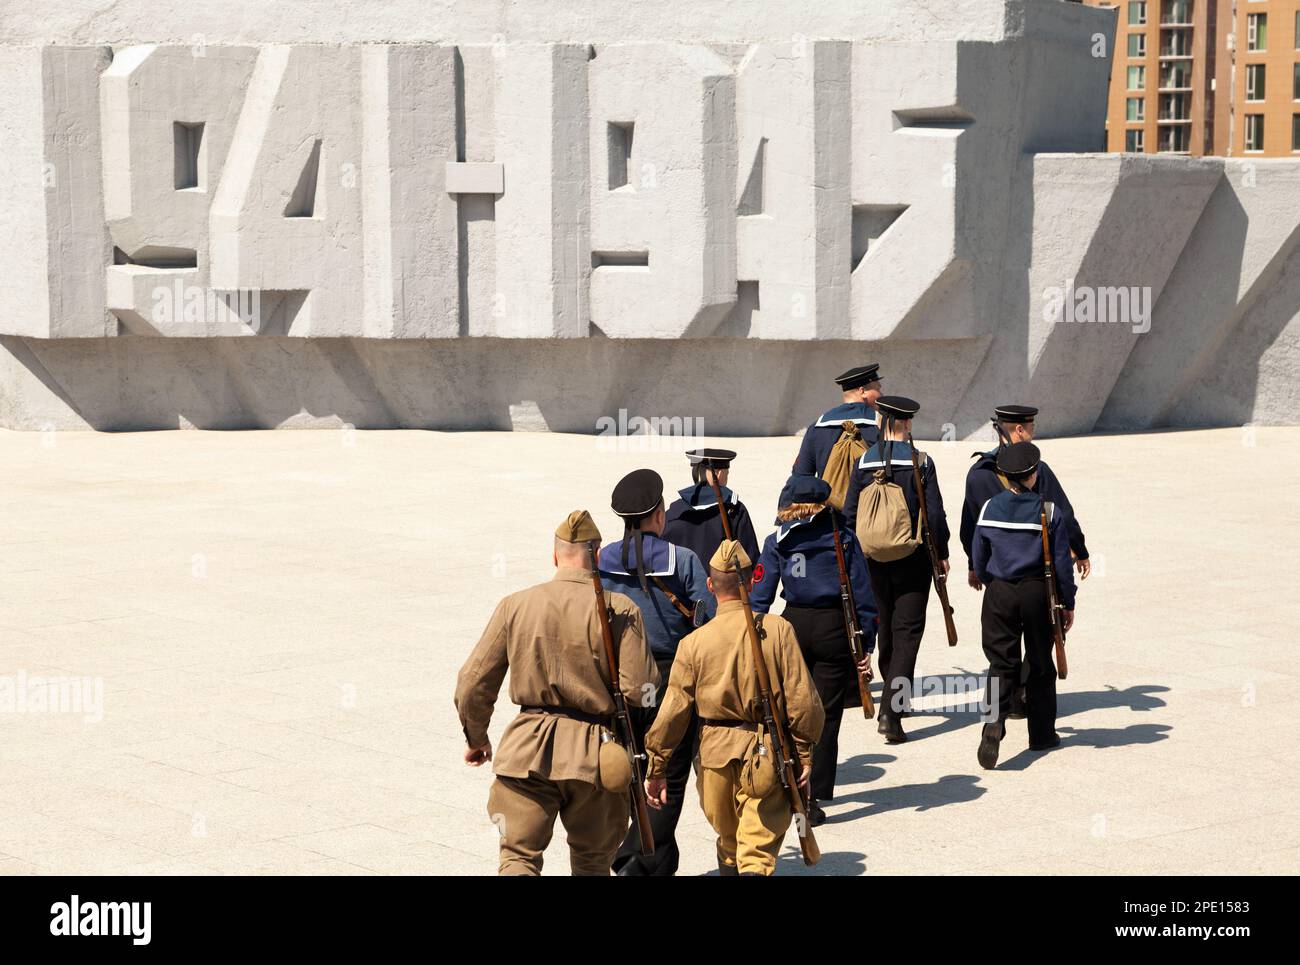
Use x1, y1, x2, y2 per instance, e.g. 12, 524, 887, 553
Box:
456, 510, 659, 875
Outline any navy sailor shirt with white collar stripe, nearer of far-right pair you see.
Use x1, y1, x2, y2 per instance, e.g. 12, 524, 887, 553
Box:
971, 489, 1075, 610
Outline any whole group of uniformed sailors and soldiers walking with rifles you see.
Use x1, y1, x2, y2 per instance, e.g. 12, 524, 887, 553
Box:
456, 364, 1089, 875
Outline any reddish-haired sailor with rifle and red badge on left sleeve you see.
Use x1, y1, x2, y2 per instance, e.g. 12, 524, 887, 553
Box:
749, 475, 876, 826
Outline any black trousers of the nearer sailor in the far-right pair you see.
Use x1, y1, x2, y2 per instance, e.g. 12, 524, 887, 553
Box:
980, 576, 1056, 744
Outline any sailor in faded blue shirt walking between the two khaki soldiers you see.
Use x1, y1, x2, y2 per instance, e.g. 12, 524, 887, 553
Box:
597, 469, 716, 875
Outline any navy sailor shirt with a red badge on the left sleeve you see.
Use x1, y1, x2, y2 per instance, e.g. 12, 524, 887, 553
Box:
749, 507, 878, 653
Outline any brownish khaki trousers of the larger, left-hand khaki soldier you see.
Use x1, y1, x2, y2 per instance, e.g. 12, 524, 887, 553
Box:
488, 775, 628, 877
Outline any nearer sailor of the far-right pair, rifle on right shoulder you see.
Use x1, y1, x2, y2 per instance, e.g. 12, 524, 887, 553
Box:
971, 442, 1075, 767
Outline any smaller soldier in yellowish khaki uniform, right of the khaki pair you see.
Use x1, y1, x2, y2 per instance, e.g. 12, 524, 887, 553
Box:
646, 540, 826, 875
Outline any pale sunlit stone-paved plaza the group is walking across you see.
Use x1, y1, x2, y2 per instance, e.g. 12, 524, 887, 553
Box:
0, 428, 1300, 874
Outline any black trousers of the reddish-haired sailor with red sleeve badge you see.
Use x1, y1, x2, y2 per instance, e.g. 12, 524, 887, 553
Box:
781, 605, 858, 801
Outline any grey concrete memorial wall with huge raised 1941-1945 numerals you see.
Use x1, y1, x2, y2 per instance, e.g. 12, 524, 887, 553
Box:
0, 0, 1300, 437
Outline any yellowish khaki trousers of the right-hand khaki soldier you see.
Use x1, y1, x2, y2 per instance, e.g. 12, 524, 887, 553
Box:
699, 761, 790, 874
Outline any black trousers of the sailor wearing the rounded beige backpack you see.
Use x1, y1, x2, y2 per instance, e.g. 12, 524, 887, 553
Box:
867, 546, 935, 719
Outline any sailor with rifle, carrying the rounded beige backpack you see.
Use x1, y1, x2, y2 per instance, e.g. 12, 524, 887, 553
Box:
844, 395, 948, 744
